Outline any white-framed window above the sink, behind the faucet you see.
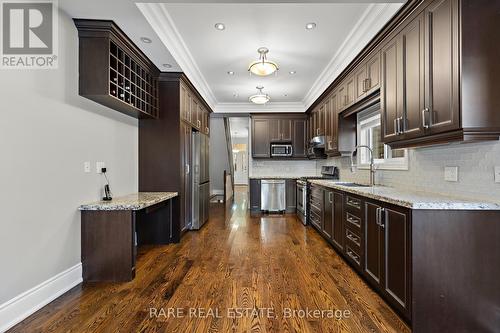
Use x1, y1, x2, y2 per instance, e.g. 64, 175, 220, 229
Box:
357, 104, 408, 170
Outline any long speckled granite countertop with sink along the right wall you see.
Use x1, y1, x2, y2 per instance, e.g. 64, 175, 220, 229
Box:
310, 180, 500, 210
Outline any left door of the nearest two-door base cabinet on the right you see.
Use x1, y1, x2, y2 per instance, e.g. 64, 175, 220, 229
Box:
363, 202, 383, 285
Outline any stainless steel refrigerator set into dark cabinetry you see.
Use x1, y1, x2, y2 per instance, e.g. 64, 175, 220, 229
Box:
191, 132, 210, 230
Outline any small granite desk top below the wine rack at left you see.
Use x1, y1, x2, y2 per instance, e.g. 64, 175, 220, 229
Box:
78, 192, 178, 210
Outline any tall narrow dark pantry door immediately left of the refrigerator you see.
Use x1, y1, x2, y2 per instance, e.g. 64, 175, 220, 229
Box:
180, 123, 192, 232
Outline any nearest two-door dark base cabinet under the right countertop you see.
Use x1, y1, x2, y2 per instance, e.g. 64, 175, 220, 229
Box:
363, 201, 411, 316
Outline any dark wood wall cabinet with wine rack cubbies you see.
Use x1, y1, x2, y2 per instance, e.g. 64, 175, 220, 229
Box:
74, 19, 160, 118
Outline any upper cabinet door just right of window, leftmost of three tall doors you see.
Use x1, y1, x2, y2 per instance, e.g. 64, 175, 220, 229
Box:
380, 36, 403, 142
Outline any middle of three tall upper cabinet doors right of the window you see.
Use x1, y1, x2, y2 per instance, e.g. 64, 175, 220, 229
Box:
400, 14, 425, 139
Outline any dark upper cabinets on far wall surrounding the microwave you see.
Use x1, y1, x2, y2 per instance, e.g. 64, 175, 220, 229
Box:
251, 114, 307, 159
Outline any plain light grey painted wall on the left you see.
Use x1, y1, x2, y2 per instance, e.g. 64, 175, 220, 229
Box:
0, 10, 138, 308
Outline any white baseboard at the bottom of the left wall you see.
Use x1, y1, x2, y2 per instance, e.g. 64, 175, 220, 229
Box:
0, 263, 83, 332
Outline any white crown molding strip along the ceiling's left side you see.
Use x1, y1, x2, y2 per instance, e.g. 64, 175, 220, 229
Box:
136, 3, 217, 110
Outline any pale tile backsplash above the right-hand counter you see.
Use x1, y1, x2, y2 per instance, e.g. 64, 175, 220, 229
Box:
318, 141, 500, 202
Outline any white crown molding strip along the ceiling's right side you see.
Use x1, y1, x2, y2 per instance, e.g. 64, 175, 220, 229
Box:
302, 3, 401, 110
